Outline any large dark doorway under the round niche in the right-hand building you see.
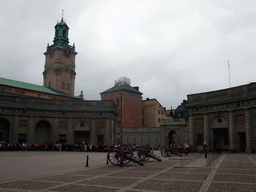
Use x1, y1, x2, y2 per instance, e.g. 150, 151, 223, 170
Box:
212, 128, 229, 151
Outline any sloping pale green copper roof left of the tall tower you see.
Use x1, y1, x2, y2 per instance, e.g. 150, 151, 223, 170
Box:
0, 77, 59, 95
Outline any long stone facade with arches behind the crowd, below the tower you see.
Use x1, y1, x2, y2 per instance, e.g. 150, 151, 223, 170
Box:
0, 92, 117, 144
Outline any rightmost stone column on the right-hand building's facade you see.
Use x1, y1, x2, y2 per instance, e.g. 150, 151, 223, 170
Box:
245, 109, 252, 153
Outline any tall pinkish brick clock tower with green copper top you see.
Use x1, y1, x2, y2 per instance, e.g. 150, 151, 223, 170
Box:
43, 17, 77, 96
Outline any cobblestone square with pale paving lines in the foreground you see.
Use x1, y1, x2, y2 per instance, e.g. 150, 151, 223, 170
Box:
0, 152, 256, 192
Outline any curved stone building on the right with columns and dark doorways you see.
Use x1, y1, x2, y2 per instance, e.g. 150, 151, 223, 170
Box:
186, 83, 256, 153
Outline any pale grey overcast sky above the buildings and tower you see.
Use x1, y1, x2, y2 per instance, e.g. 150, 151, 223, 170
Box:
0, 0, 256, 109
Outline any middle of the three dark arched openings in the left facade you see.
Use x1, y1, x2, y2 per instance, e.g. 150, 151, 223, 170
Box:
34, 121, 51, 143
